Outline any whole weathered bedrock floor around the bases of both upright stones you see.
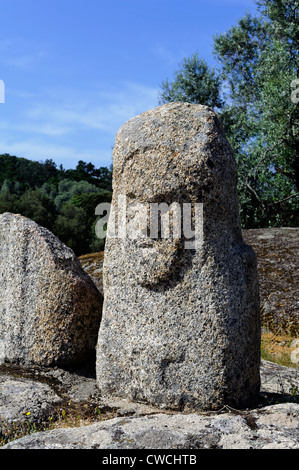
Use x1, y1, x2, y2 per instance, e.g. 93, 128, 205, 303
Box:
0, 361, 299, 449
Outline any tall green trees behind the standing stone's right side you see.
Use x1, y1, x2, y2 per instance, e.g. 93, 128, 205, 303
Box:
160, 0, 299, 228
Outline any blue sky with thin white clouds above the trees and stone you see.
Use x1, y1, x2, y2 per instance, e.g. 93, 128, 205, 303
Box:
0, 0, 256, 169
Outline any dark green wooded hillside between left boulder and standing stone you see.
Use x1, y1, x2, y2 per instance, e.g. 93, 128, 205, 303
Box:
0, 154, 112, 256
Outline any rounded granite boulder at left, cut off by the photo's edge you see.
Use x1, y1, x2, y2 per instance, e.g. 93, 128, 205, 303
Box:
0, 213, 102, 366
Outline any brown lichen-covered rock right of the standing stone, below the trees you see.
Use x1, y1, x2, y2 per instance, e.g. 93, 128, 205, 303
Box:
243, 227, 299, 337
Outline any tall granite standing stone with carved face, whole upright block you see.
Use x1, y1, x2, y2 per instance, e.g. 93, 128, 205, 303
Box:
97, 103, 260, 411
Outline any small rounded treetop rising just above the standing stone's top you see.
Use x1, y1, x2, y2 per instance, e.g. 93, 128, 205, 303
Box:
160, 53, 223, 108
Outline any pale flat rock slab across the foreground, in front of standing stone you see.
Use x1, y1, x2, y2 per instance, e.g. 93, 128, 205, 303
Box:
4, 403, 299, 449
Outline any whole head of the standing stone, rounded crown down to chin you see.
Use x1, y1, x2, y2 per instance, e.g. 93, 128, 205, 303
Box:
109, 104, 238, 285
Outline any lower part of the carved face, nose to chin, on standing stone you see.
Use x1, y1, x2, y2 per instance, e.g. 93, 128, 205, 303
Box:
110, 189, 203, 287
